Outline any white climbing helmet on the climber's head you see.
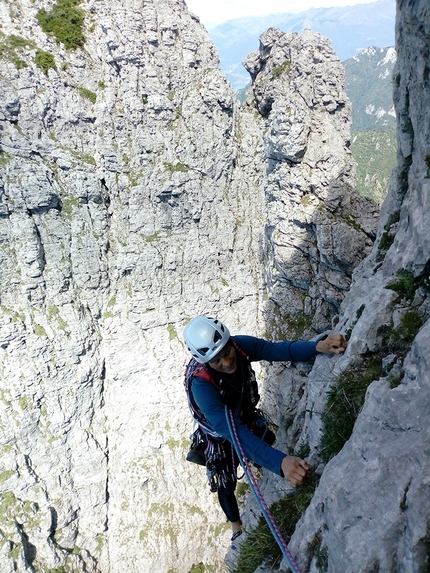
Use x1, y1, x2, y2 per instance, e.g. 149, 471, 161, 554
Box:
184, 316, 230, 364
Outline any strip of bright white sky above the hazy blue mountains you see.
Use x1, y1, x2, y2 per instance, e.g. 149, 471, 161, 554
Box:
185, 0, 382, 27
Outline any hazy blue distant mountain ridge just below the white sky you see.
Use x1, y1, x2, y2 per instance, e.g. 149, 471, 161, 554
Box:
209, 0, 396, 90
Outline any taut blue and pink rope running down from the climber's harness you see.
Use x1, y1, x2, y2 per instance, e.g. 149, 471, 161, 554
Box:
225, 406, 302, 573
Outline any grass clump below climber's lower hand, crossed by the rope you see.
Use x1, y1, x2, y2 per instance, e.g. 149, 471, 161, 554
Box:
235, 476, 317, 573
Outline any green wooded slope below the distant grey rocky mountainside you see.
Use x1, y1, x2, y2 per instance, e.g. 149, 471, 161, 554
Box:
351, 128, 397, 204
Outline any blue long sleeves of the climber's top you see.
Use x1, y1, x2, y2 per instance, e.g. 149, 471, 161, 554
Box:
191, 336, 318, 475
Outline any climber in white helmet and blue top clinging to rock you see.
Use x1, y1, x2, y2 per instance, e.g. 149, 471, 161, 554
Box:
184, 316, 347, 541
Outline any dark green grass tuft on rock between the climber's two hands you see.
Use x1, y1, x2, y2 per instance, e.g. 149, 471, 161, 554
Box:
321, 354, 383, 462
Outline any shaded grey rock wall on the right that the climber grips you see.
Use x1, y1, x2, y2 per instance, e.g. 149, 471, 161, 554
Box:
282, 0, 430, 573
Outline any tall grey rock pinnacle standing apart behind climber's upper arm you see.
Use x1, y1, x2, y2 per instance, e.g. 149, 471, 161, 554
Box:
245, 29, 377, 338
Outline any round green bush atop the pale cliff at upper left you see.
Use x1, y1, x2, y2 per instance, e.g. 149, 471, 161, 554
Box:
36, 0, 85, 50
